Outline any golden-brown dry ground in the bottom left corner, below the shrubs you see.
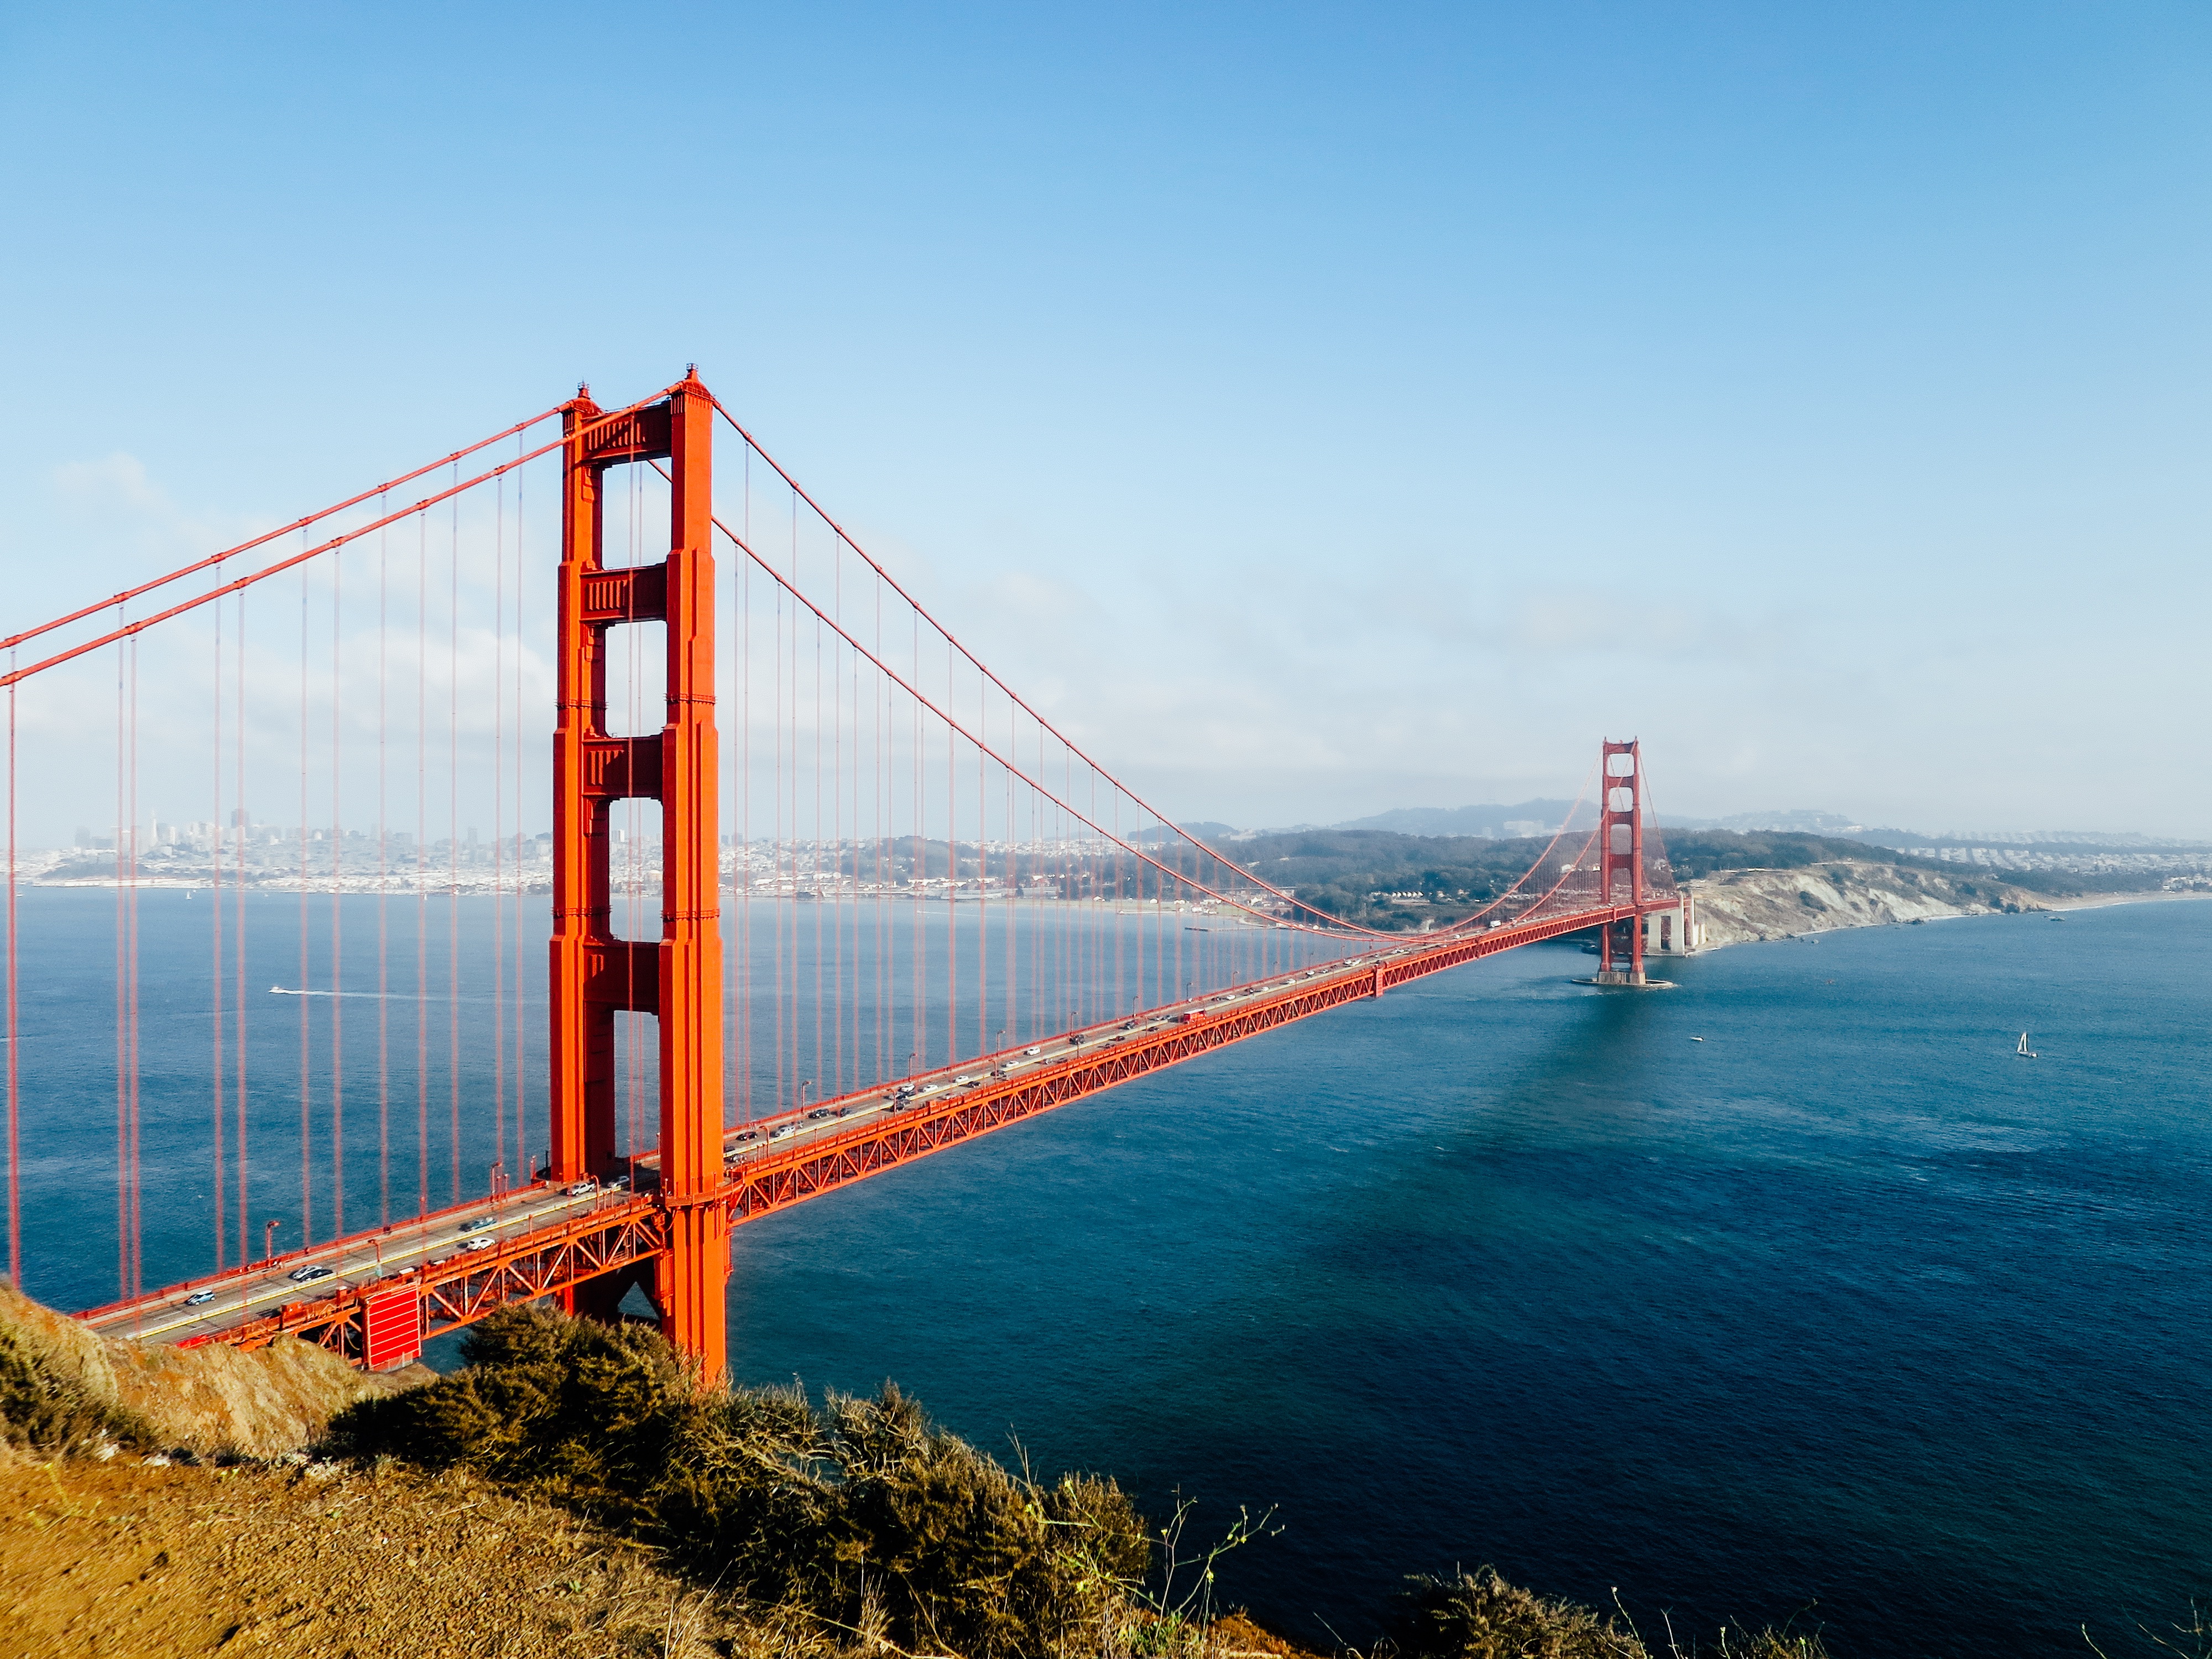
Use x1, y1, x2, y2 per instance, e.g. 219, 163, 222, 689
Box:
0, 1453, 779, 1659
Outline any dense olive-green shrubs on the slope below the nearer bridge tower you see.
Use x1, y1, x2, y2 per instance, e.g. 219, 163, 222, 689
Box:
332, 1305, 1148, 1659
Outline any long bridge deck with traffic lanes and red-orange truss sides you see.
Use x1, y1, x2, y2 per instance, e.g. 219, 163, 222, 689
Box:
77, 896, 1679, 1360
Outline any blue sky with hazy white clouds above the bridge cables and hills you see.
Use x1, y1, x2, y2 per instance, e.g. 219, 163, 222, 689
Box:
0, 0, 2212, 836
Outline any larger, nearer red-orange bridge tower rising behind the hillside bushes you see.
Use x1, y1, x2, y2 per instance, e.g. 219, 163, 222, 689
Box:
551, 372, 730, 1378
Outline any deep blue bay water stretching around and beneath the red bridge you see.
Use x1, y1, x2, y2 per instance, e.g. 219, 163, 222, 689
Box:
20, 889, 2212, 1659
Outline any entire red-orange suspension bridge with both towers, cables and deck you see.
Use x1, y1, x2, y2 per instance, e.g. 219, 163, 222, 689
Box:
0, 374, 1694, 1374
